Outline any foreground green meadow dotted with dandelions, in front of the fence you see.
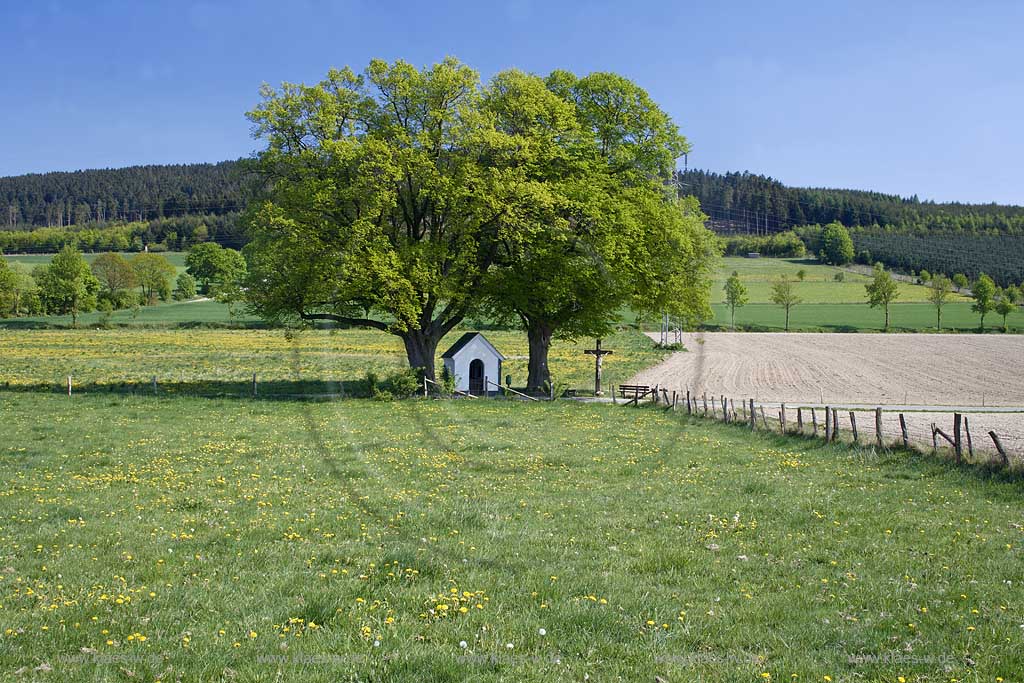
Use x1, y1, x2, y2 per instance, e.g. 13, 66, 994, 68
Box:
0, 391, 1024, 683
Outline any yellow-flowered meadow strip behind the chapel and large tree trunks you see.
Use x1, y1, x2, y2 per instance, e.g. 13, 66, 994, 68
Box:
0, 327, 665, 394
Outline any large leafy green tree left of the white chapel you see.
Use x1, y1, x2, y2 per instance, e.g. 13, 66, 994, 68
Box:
246, 58, 527, 378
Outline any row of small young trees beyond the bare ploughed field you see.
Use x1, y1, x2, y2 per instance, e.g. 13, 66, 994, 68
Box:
724, 263, 1024, 332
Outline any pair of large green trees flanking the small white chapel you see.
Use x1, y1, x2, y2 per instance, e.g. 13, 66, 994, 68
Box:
245, 58, 718, 389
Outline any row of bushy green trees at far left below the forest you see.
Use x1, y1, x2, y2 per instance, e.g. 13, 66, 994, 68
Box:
0, 243, 246, 325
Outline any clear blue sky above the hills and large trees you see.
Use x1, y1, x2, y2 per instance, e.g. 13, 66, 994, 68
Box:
0, 0, 1024, 204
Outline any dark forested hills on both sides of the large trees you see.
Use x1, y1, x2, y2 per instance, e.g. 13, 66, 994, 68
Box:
0, 161, 1024, 234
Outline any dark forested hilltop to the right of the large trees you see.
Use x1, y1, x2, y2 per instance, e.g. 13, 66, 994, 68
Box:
677, 170, 1024, 234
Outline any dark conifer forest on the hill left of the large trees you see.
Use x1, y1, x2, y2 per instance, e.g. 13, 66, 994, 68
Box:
0, 161, 243, 228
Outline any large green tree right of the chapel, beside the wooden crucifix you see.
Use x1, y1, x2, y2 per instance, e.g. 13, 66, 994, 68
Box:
483, 71, 717, 390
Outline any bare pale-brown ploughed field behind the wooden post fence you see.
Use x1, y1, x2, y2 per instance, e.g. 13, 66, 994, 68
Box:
631, 332, 1024, 457
